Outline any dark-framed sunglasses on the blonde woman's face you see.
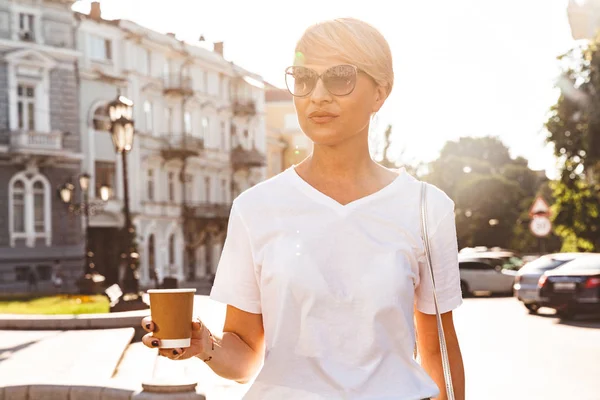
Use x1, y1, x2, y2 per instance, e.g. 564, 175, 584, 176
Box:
285, 64, 361, 97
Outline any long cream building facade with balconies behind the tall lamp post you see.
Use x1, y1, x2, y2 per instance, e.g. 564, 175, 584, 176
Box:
77, 3, 266, 287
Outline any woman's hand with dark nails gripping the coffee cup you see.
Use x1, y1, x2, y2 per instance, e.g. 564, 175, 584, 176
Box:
142, 317, 213, 360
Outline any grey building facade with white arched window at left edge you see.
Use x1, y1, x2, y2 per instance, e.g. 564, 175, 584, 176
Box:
0, 0, 84, 291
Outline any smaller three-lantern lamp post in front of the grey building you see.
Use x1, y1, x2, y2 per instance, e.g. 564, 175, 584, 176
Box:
58, 178, 110, 278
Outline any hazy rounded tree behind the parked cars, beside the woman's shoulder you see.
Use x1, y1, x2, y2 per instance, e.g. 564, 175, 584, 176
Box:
425, 137, 548, 252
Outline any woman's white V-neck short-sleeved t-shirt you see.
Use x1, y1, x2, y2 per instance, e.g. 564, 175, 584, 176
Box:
211, 167, 462, 400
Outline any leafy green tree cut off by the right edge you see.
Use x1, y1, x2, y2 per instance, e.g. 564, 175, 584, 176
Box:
546, 38, 600, 251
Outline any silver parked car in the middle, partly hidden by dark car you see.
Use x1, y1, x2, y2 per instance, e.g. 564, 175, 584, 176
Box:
513, 253, 589, 313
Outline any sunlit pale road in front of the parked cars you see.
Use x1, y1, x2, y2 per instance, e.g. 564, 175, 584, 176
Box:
454, 298, 600, 400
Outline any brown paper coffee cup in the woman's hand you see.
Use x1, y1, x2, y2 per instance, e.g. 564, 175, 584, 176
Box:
148, 289, 196, 349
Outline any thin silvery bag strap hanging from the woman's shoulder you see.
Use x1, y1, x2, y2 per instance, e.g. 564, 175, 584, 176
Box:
420, 182, 455, 400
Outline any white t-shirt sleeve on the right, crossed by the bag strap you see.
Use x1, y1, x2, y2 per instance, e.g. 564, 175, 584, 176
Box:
415, 198, 462, 314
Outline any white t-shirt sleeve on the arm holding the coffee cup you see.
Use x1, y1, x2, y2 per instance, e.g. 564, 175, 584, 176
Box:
210, 204, 262, 314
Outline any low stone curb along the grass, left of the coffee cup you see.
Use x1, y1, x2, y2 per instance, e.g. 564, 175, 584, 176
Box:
0, 309, 150, 330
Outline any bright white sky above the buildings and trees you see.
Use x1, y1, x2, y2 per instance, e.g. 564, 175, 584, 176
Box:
74, 0, 575, 178
